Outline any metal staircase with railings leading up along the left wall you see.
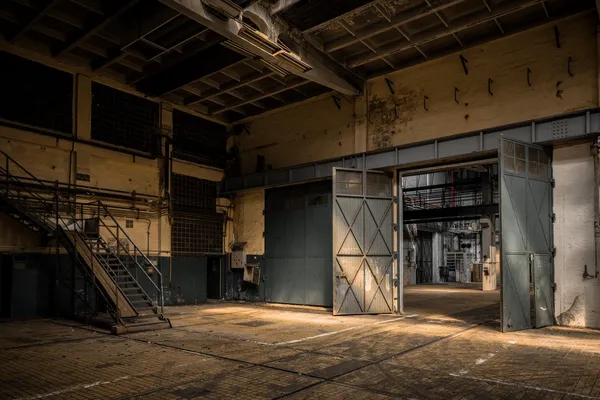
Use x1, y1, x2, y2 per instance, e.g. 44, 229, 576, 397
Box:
0, 150, 171, 334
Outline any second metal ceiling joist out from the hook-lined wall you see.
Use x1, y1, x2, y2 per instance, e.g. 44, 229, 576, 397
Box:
324, 0, 466, 53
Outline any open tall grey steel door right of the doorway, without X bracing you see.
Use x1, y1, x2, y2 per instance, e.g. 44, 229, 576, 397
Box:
500, 138, 554, 332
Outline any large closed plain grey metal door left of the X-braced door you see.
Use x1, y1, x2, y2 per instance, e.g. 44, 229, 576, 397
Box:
263, 182, 332, 307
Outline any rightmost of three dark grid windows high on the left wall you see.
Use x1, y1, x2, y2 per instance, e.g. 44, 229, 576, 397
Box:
173, 110, 227, 168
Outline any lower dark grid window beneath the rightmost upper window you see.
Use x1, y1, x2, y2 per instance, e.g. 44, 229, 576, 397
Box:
171, 174, 224, 255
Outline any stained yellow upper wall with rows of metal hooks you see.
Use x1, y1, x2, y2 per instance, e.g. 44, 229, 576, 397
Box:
367, 11, 598, 150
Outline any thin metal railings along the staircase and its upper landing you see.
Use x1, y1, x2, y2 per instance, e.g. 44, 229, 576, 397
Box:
0, 150, 164, 323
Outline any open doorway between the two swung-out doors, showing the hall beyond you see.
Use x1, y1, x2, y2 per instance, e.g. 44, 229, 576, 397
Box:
401, 160, 501, 323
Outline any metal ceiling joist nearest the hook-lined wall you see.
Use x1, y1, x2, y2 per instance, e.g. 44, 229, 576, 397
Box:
348, 0, 543, 68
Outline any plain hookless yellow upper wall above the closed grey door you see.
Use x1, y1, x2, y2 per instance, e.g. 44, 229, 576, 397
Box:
238, 96, 354, 174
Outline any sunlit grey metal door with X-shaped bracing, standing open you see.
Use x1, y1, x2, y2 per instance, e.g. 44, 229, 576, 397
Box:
333, 168, 394, 315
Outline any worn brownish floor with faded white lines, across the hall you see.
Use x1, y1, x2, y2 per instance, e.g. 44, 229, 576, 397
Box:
0, 285, 600, 399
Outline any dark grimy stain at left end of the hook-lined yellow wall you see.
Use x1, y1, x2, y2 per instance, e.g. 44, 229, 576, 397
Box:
367, 86, 419, 150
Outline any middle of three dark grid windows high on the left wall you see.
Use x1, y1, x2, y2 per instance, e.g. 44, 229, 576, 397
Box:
92, 82, 160, 154
